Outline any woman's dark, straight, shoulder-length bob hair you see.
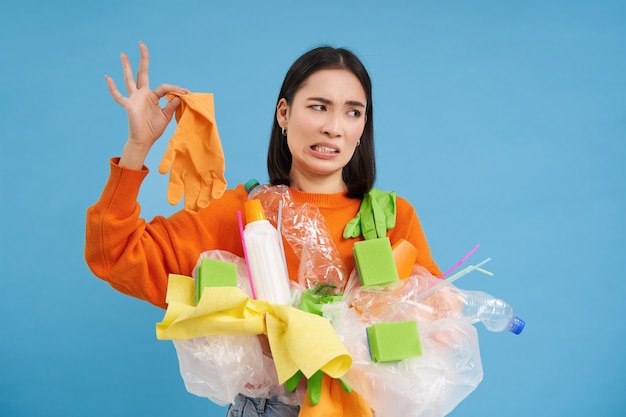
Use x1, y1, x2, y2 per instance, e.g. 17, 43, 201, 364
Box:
267, 46, 376, 198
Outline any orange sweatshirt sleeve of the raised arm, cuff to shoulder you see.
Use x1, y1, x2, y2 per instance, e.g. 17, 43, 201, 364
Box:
85, 158, 247, 308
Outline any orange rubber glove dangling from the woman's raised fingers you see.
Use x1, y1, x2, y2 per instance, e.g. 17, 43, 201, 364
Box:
159, 93, 226, 213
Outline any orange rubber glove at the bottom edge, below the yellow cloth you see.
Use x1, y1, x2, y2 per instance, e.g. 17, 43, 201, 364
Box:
298, 374, 372, 417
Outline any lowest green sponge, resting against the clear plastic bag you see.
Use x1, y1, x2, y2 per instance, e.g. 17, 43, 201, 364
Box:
367, 320, 422, 362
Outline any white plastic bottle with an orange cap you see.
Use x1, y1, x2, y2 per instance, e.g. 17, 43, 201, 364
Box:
243, 199, 291, 305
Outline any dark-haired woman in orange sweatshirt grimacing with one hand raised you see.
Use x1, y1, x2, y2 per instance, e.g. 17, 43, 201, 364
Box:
85, 44, 441, 415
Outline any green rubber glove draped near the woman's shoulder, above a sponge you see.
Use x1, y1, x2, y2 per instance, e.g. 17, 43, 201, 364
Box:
343, 188, 396, 240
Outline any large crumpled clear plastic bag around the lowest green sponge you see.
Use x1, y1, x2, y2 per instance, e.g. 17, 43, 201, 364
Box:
322, 267, 483, 417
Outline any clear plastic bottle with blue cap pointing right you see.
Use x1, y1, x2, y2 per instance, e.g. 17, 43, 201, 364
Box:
458, 289, 526, 334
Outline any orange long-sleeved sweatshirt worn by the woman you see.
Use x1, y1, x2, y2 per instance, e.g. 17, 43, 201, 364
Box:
85, 159, 441, 308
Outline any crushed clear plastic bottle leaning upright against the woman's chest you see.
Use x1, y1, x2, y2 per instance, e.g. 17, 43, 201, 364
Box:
250, 185, 348, 294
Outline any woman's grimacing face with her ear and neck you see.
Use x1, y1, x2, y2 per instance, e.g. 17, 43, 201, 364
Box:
277, 69, 367, 192
